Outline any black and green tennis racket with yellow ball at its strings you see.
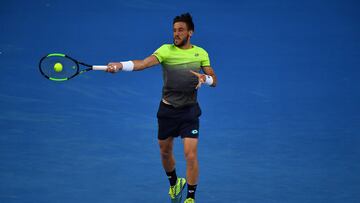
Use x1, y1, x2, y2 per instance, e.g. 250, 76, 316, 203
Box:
39, 53, 107, 82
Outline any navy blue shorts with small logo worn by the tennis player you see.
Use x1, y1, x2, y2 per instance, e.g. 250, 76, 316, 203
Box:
157, 102, 201, 140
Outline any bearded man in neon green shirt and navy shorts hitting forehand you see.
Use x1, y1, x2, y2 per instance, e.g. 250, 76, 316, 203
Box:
106, 13, 217, 203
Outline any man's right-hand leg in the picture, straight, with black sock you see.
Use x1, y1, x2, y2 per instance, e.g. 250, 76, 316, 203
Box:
184, 137, 199, 199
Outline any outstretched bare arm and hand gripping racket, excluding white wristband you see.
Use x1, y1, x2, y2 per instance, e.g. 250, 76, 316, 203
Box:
106, 55, 160, 73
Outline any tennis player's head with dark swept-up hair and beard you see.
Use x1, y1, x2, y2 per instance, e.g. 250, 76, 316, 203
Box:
173, 13, 194, 47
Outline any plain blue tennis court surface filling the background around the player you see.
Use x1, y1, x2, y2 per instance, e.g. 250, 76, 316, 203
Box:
0, 0, 360, 203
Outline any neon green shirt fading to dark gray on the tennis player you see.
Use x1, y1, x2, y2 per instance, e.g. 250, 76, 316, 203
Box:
153, 44, 210, 107
